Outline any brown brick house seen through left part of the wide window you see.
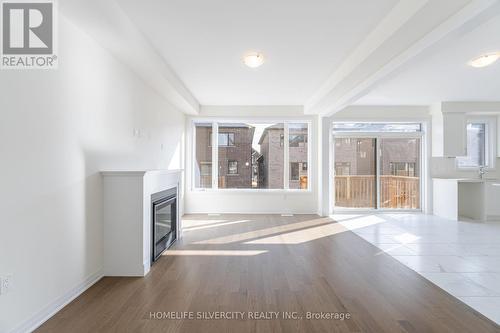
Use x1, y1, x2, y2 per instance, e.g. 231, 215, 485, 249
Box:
196, 124, 255, 188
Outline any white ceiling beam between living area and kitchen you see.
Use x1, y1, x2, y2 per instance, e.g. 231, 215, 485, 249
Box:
305, 0, 499, 116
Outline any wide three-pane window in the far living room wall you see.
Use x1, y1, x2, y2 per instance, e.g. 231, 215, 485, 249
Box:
194, 120, 309, 190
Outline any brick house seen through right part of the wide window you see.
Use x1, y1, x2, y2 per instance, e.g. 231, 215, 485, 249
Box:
259, 124, 308, 189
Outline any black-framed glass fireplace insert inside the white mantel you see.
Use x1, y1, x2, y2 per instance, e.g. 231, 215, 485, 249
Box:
151, 188, 177, 263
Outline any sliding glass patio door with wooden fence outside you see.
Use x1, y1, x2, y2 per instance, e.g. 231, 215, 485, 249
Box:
332, 123, 422, 210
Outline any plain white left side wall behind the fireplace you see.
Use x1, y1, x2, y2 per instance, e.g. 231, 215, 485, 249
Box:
0, 16, 185, 332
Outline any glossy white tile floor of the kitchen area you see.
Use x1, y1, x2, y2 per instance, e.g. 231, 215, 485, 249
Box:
332, 213, 500, 324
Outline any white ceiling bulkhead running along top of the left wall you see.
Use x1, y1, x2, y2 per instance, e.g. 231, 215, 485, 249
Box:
59, 0, 200, 115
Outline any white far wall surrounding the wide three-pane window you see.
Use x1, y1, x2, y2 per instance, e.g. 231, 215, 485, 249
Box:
184, 106, 318, 214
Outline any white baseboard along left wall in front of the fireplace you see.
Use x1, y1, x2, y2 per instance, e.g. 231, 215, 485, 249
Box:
10, 270, 103, 333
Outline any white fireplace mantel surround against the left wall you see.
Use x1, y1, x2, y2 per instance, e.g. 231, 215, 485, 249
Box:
101, 170, 182, 276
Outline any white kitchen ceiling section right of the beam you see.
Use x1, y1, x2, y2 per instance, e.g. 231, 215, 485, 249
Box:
355, 9, 500, 105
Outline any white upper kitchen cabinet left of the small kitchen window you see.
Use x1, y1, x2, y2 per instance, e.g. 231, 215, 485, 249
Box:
443, 112, 467, 157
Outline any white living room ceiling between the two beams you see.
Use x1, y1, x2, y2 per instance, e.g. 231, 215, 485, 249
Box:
118, 0, 398, 105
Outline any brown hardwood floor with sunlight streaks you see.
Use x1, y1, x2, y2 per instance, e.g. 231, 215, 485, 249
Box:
37, 215, 499, 333
